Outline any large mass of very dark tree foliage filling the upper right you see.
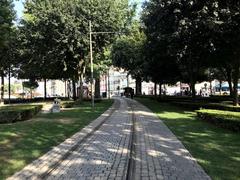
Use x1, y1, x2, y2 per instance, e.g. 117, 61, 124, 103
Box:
142, 0, 240, 105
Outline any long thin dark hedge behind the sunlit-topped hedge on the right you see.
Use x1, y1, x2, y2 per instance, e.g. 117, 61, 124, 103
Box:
171, 102, 240, 112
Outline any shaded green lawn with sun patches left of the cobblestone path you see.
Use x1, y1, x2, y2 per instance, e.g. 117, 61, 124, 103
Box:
0, 100, 113, 179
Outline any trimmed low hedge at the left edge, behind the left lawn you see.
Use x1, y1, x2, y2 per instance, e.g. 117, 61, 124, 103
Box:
0, 105, 42, 123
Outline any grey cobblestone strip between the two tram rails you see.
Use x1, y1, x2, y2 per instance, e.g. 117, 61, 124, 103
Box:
47, 99, 132, 179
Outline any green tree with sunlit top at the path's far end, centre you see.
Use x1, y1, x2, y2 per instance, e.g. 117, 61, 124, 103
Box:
112, 23, 145, 95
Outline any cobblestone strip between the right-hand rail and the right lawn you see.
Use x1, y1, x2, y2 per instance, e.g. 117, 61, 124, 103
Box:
129, 100, 210, 180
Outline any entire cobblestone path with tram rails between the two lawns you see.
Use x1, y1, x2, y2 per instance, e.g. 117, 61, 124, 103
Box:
10, 98, 210, 180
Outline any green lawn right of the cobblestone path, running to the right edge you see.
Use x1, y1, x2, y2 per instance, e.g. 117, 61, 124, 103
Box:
137, 98, 240, 180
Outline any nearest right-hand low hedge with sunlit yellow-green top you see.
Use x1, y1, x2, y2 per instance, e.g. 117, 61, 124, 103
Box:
196, 109, 240, 132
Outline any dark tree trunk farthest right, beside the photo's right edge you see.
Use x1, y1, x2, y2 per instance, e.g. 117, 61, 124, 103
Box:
233, 65, 240, 106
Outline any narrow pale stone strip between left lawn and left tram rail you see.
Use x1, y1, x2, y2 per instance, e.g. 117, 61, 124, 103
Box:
7, 100, 117, 180
